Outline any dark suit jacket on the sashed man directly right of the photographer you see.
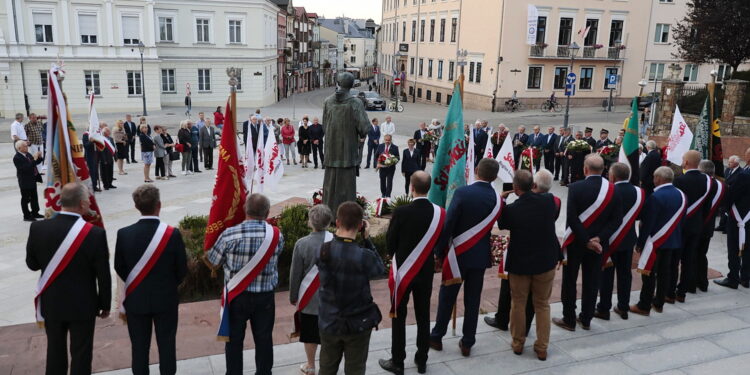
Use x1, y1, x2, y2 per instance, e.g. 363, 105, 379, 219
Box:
386, 199, 435, 284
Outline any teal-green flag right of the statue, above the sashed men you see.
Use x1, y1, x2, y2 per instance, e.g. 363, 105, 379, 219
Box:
428, 85, 466, 207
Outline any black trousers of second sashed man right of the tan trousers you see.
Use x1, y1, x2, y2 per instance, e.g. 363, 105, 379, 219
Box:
596, 245, 633, 313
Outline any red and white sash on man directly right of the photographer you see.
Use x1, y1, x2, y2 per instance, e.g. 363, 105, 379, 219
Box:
388, 204, 445, 318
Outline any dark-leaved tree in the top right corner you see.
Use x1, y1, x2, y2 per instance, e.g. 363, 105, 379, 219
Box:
673, 0, 750, 74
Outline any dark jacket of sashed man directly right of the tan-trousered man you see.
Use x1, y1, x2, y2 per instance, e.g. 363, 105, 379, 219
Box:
567, 176, 622, 250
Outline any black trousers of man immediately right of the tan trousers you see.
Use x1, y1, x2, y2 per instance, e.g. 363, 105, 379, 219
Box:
560, 246, 602, 327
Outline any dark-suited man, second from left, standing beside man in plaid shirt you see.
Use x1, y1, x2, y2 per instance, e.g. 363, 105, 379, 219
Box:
115, 185, 187, 375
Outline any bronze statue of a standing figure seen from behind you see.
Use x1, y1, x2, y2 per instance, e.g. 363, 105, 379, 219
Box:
323, 72, 370, 213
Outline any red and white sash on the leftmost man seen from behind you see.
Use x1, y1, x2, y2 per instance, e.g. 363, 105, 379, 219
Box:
34, 218, 94, 327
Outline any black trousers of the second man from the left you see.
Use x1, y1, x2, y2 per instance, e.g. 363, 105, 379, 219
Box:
127, 305, 177, 375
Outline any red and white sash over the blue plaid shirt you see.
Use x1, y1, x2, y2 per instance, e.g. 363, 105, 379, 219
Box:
217, 223, 280, 342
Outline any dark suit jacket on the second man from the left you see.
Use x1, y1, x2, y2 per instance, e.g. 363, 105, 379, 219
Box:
115, 218, 187, 314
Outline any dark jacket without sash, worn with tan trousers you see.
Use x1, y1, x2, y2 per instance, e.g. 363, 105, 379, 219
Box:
498, 192, 560, 275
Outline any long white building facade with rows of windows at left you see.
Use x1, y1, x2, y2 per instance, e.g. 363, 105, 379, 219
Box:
0, 0, 279, 117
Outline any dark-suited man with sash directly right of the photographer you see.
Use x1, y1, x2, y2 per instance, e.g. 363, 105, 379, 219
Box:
379, 171, 442, 375
